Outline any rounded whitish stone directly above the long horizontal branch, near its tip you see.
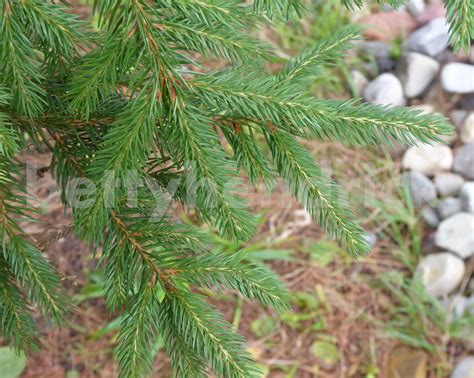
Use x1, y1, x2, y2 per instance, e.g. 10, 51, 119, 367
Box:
364, 73, 406, 106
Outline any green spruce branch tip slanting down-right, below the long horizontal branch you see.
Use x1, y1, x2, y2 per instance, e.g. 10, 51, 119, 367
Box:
266, 130, 368, 256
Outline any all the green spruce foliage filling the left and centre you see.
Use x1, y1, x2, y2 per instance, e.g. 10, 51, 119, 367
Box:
0, 0, 466, 377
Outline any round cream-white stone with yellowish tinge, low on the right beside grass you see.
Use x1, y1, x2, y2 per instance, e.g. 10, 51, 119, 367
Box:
415, 252, 466, 297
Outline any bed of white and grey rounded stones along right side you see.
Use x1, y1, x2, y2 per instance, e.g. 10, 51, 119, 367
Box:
354, 0, 474, 378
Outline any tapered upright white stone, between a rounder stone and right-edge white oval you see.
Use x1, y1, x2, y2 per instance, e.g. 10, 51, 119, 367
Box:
405, 52, 439, 98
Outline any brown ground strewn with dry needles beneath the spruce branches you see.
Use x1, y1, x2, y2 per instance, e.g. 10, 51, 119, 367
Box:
19, 144, 465, 378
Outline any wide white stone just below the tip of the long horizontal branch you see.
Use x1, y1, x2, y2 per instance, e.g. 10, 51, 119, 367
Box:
402, 144, 453, 175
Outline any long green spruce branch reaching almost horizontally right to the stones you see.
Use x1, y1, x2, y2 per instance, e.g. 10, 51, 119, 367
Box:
194, 74, 452, 144
